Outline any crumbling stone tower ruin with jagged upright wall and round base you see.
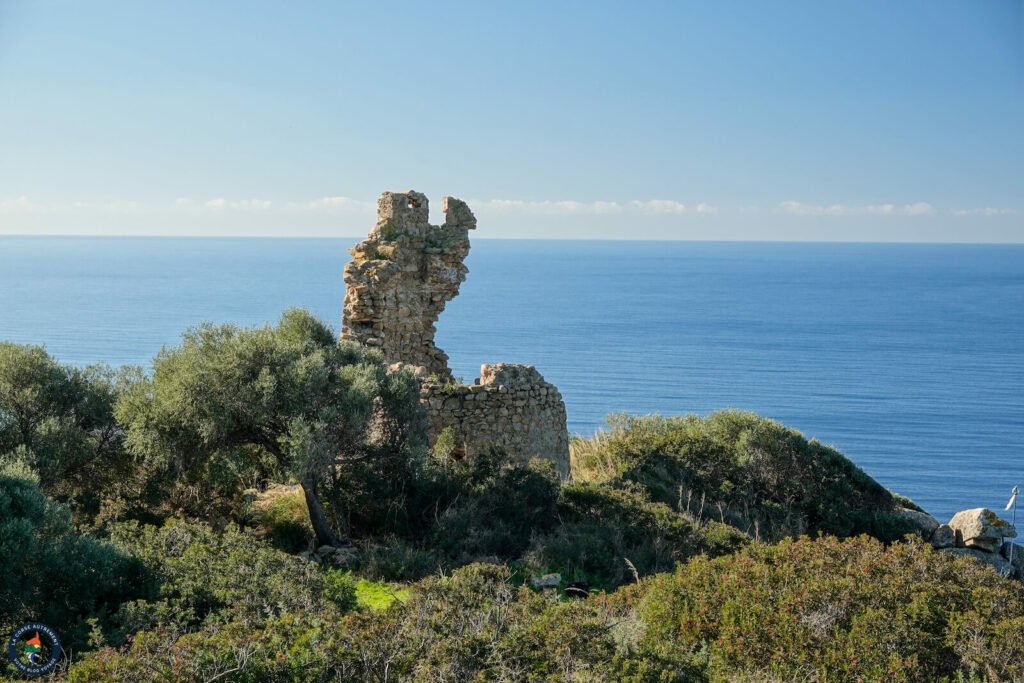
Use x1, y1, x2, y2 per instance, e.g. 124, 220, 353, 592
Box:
341, 190, 569, 476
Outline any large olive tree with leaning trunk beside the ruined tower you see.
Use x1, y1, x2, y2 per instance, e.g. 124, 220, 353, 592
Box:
117, 309, 425, 545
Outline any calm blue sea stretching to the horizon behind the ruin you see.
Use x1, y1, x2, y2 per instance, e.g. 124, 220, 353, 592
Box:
0, 237, 1024, 521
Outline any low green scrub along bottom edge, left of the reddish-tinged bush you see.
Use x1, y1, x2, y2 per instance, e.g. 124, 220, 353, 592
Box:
69, 564, 672, 683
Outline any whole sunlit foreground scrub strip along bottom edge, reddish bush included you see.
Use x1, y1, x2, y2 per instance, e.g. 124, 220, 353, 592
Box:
58, 537, 1024, 681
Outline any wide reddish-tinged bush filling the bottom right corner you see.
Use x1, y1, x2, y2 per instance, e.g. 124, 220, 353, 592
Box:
635, 536, 1024, 681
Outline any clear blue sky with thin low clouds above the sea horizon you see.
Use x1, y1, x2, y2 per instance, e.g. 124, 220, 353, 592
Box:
0, 0, 1024, 242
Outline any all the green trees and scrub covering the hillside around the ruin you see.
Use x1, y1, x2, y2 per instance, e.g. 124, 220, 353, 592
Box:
0, 310, 1024, 681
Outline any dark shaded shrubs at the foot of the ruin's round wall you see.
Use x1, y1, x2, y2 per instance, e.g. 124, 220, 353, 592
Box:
352, 450, 749, 588
